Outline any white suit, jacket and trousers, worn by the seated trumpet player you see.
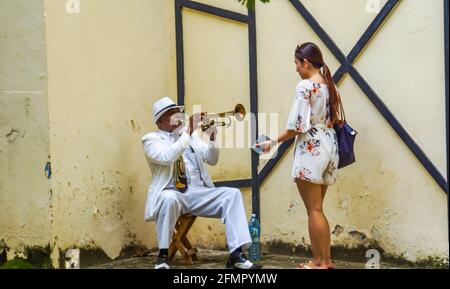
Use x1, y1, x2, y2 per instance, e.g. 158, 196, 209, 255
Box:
142, 130, 251, 252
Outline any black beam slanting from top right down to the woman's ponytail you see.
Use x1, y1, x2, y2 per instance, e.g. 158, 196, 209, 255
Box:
333, 0, 400, 83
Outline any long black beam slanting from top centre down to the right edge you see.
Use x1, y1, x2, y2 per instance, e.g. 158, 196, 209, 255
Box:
289, 0, 448, 194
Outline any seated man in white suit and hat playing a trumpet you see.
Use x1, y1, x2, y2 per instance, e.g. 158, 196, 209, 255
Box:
142, 97, 261, 269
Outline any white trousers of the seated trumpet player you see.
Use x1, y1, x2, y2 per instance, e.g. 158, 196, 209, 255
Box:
156, 186, 251, 252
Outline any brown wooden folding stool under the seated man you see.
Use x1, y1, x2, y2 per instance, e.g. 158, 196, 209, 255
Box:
169, 215, 198, 265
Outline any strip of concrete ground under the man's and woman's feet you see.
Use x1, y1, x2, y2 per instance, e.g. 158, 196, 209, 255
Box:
88, 249, 412, 269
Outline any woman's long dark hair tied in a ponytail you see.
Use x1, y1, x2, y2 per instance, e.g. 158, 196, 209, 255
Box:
295, 42, 341, 125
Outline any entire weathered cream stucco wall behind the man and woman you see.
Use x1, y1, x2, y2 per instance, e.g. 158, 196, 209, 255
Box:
0, 0, 448, 266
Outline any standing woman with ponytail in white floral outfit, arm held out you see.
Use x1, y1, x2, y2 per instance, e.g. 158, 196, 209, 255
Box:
258, 43, 340, 269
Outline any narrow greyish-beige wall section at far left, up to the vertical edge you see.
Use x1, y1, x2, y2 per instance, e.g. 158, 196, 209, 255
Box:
0, 0, 51, 258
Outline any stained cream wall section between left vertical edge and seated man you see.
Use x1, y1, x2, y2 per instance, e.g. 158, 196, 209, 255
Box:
45, 0, 175, 266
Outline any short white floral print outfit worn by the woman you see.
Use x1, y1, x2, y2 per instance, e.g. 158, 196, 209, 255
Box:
287, 79, 339, 185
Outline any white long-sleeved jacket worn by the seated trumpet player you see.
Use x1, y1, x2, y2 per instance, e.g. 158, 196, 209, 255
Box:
142, 130, 219, 221
